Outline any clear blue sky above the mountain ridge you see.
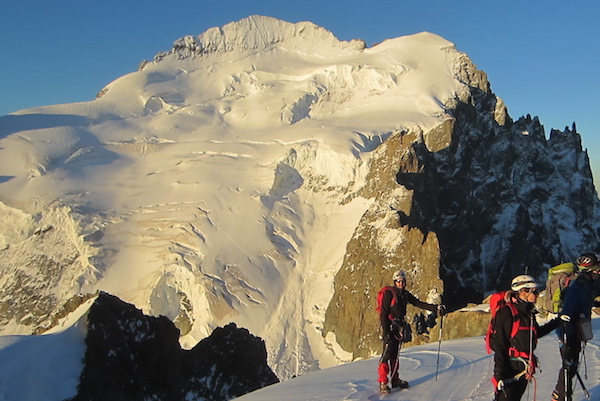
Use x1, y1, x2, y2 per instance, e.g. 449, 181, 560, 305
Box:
0, 0, 600, 182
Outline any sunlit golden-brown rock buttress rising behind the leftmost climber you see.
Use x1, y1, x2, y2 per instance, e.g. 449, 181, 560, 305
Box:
324, 133, 444, 357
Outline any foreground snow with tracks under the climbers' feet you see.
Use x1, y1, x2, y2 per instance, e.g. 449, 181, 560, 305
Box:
237, 319, 600, 401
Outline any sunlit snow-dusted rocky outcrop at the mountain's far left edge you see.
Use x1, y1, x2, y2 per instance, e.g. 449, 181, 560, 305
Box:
0, 204, 106, 334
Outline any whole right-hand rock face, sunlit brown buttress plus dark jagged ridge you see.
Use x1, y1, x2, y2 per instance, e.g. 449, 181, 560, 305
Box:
325, 80, 600, 357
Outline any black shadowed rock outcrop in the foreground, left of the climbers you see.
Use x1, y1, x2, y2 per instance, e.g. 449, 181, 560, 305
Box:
71, 293, 278, 401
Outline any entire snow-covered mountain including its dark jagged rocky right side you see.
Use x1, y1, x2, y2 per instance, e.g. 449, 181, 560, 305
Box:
0, 16, 600, 379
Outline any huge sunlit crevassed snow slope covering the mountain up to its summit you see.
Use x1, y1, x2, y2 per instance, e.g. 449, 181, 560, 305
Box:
0, 16, 468, 378
